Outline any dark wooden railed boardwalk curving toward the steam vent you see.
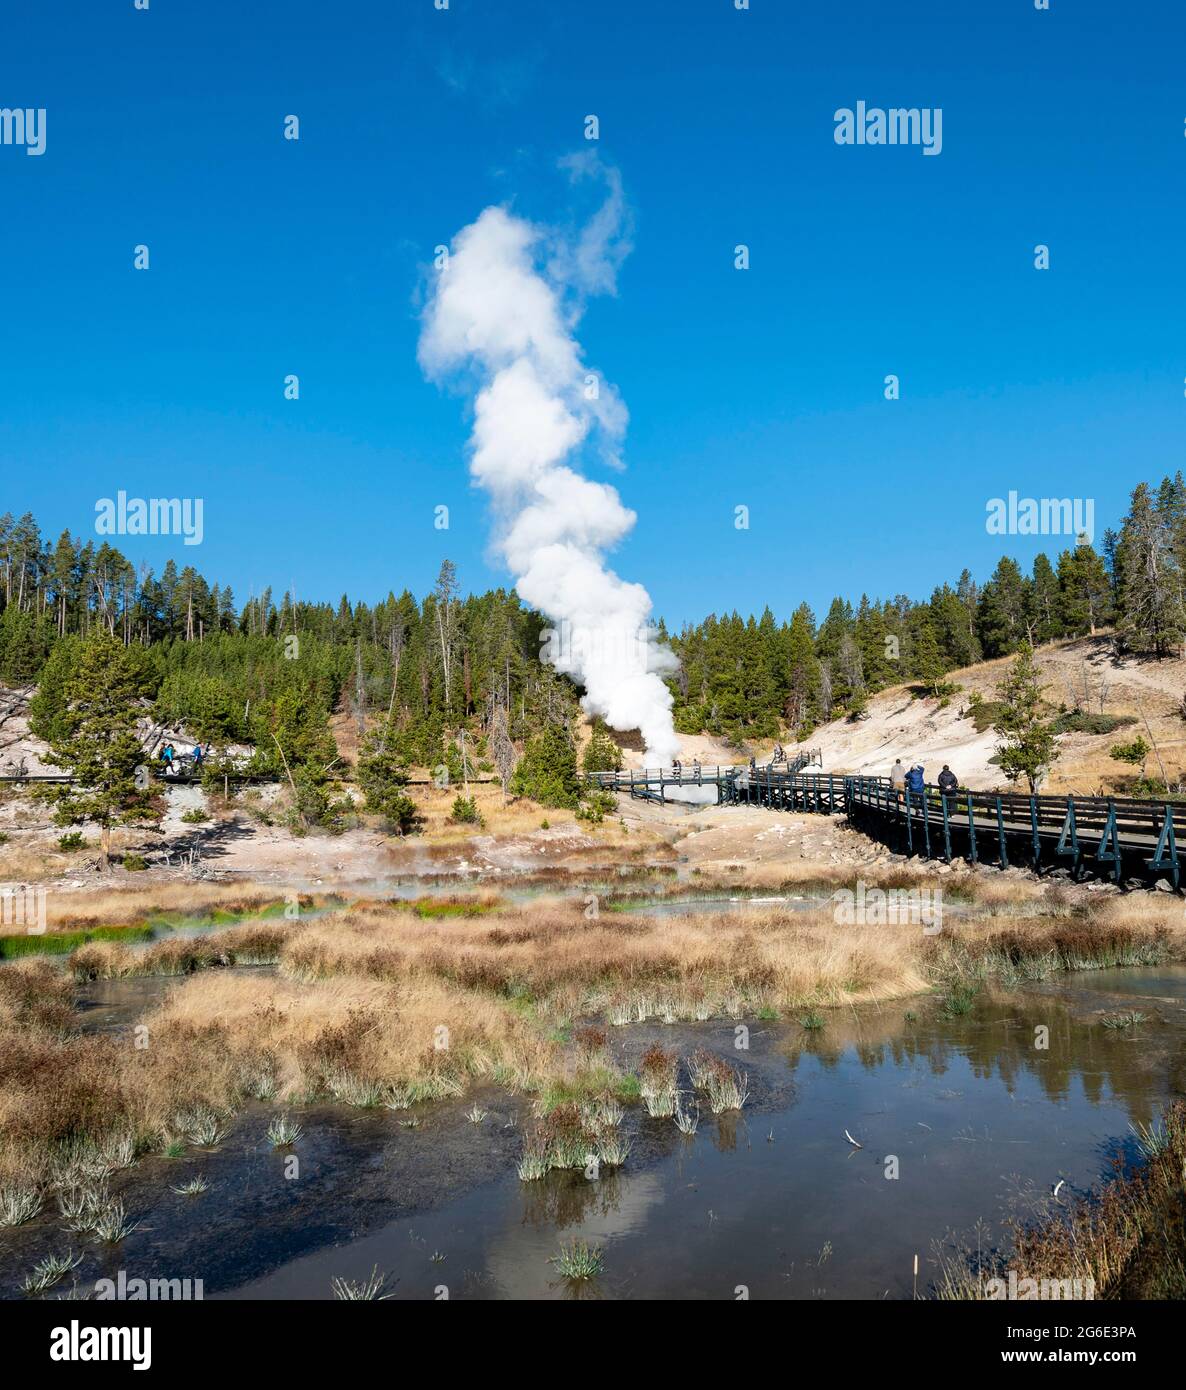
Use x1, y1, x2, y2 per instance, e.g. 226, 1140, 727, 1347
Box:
588, 753, 1186, 888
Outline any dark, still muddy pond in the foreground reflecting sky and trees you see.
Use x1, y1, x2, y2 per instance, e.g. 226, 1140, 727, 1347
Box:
0, 966, 1186, 1298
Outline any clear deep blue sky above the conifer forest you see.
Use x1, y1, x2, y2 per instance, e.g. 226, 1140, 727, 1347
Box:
0, 0, 1186, 624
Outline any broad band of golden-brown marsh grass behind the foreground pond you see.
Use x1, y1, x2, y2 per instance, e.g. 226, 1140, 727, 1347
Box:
0, 870, 1186, 1219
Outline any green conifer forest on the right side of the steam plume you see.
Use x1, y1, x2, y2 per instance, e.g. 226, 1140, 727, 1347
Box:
669, 473, 1186, 739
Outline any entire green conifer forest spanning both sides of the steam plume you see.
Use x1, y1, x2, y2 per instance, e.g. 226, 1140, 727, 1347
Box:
0, 474, 1186, 803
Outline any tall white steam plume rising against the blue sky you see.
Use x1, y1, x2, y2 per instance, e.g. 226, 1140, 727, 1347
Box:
420, 169, 679, 763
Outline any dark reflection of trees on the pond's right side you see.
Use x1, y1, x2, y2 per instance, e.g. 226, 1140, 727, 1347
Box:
784, 995, 1186, 1123
